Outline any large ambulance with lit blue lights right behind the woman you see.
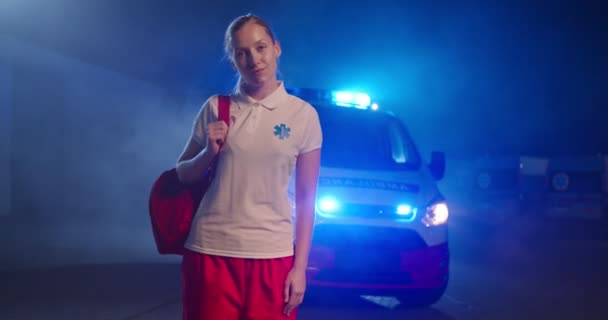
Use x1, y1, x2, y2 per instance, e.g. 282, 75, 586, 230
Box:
288, 88, 450, 306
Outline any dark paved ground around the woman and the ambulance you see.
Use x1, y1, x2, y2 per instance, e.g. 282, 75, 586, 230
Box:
0, 206, 608, 320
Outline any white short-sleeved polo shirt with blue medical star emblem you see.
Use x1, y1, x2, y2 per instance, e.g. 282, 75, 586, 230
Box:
186, 83, 322, 258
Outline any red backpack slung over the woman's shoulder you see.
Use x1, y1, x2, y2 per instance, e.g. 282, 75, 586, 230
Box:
148, 96, 230, 255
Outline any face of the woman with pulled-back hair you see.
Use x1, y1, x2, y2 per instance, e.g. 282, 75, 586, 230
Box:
232, 22, 281, 88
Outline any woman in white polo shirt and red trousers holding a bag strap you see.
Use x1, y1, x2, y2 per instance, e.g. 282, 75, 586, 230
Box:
177, 15, 322, 320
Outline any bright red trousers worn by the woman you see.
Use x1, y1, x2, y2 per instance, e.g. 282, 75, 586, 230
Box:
182, 250, 297, 320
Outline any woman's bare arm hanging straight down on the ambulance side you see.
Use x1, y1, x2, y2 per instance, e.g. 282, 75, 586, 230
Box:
285, 149, 321, 314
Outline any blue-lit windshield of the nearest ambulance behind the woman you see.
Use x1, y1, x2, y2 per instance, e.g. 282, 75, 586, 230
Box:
317, 107, 420, 170
